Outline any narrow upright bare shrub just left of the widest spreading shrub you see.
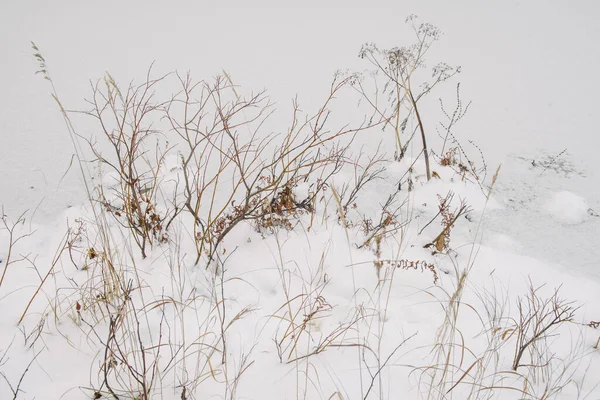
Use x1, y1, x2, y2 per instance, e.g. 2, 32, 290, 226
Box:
85, 68, 179, 258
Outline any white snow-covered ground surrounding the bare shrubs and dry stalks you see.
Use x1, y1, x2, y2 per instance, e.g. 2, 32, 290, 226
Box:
0, 0, 600, 399
